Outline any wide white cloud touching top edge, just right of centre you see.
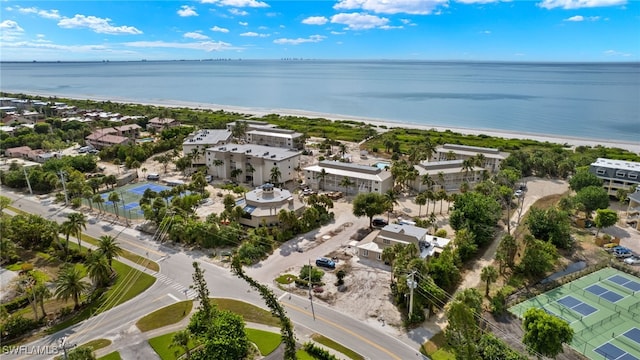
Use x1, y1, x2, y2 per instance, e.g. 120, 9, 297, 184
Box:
333, 0, 449, 15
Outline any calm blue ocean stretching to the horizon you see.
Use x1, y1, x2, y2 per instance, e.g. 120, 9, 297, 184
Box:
0, 60, 640, 142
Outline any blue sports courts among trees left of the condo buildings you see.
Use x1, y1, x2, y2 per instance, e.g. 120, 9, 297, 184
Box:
92, 182, 171, 219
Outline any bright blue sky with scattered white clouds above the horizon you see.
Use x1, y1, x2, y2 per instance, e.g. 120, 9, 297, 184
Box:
0, 0, 640, 62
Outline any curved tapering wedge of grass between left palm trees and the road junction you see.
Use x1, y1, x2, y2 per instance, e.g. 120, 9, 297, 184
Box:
47, 260, 156, 334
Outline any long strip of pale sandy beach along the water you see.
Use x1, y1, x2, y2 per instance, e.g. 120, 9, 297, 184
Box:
12, 92, 640, 154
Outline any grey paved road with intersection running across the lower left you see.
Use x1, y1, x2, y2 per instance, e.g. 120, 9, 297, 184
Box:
2, 188, 428, 359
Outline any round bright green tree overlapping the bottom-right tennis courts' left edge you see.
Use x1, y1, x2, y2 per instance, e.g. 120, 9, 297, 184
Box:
522, 308, 573, 358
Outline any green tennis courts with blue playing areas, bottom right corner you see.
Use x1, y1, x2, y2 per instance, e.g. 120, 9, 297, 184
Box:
509, 268, 640, 360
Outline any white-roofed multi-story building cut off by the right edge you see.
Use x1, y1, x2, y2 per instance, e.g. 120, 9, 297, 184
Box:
589, 158, 640, 196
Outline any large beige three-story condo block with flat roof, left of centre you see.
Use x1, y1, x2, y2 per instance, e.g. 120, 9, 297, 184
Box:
206, 144, 301, 186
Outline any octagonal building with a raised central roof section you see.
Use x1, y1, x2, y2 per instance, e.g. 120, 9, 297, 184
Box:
238, 183, 305, 227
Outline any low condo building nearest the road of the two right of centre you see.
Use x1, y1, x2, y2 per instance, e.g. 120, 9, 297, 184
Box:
412, 160, 486, 192
